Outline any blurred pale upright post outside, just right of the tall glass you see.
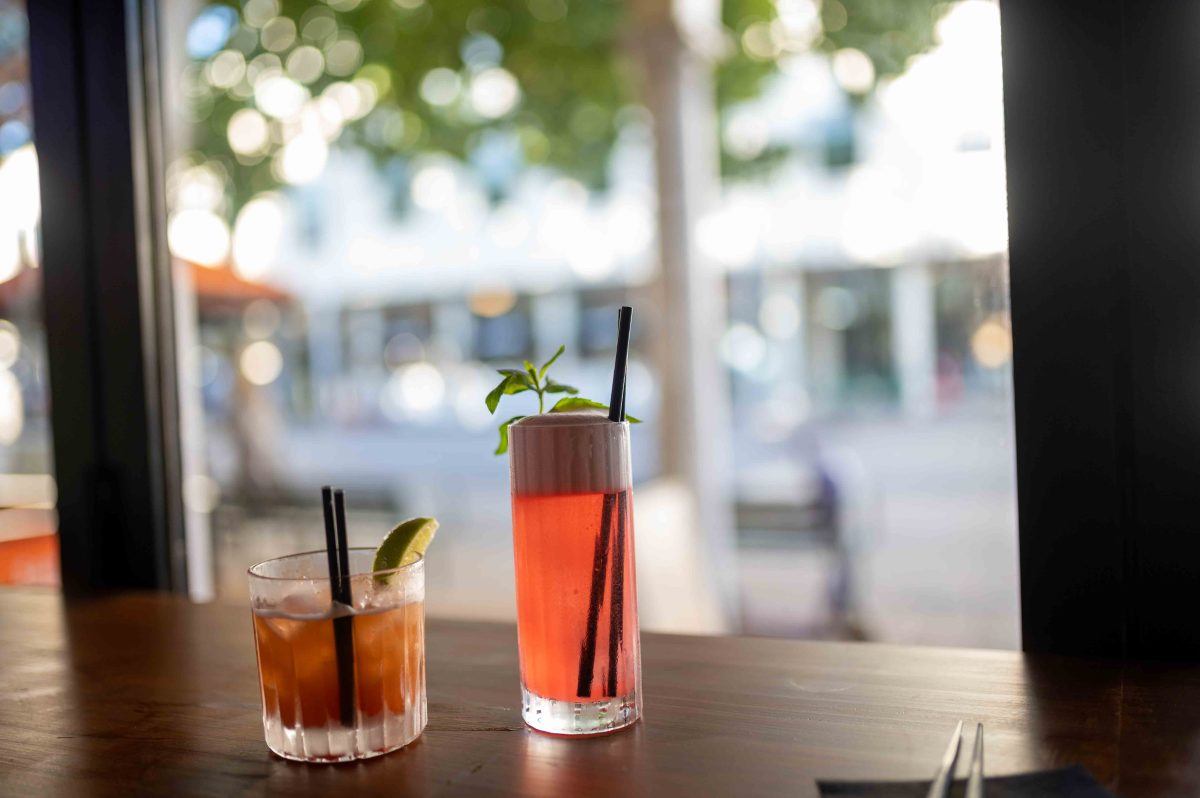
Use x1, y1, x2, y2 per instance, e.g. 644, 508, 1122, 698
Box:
632, 0, 737, 626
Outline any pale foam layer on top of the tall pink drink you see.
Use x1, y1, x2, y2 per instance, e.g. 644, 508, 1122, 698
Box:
509, 410, 629, 494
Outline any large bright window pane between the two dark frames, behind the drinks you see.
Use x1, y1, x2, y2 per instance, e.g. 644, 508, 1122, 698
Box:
167, 0, 1019, 647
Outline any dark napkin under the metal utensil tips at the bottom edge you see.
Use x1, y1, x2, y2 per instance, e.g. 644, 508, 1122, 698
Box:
817, 764, 1114, 798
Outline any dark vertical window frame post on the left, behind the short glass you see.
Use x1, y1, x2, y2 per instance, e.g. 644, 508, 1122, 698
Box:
28, 0, 187, 594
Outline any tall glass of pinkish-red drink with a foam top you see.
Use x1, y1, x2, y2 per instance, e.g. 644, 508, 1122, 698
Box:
509, 413, 642, 736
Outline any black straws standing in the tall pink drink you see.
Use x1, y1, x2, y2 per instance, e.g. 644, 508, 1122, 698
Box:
575, 305, 634, 698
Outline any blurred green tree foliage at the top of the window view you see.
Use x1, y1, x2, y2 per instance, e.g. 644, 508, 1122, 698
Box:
184, 0, 944, 211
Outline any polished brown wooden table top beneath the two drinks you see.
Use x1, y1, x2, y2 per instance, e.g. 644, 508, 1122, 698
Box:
0, 589, 1200, 798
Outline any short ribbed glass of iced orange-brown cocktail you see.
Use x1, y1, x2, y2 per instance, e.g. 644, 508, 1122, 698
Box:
250, 548, 426, 762
